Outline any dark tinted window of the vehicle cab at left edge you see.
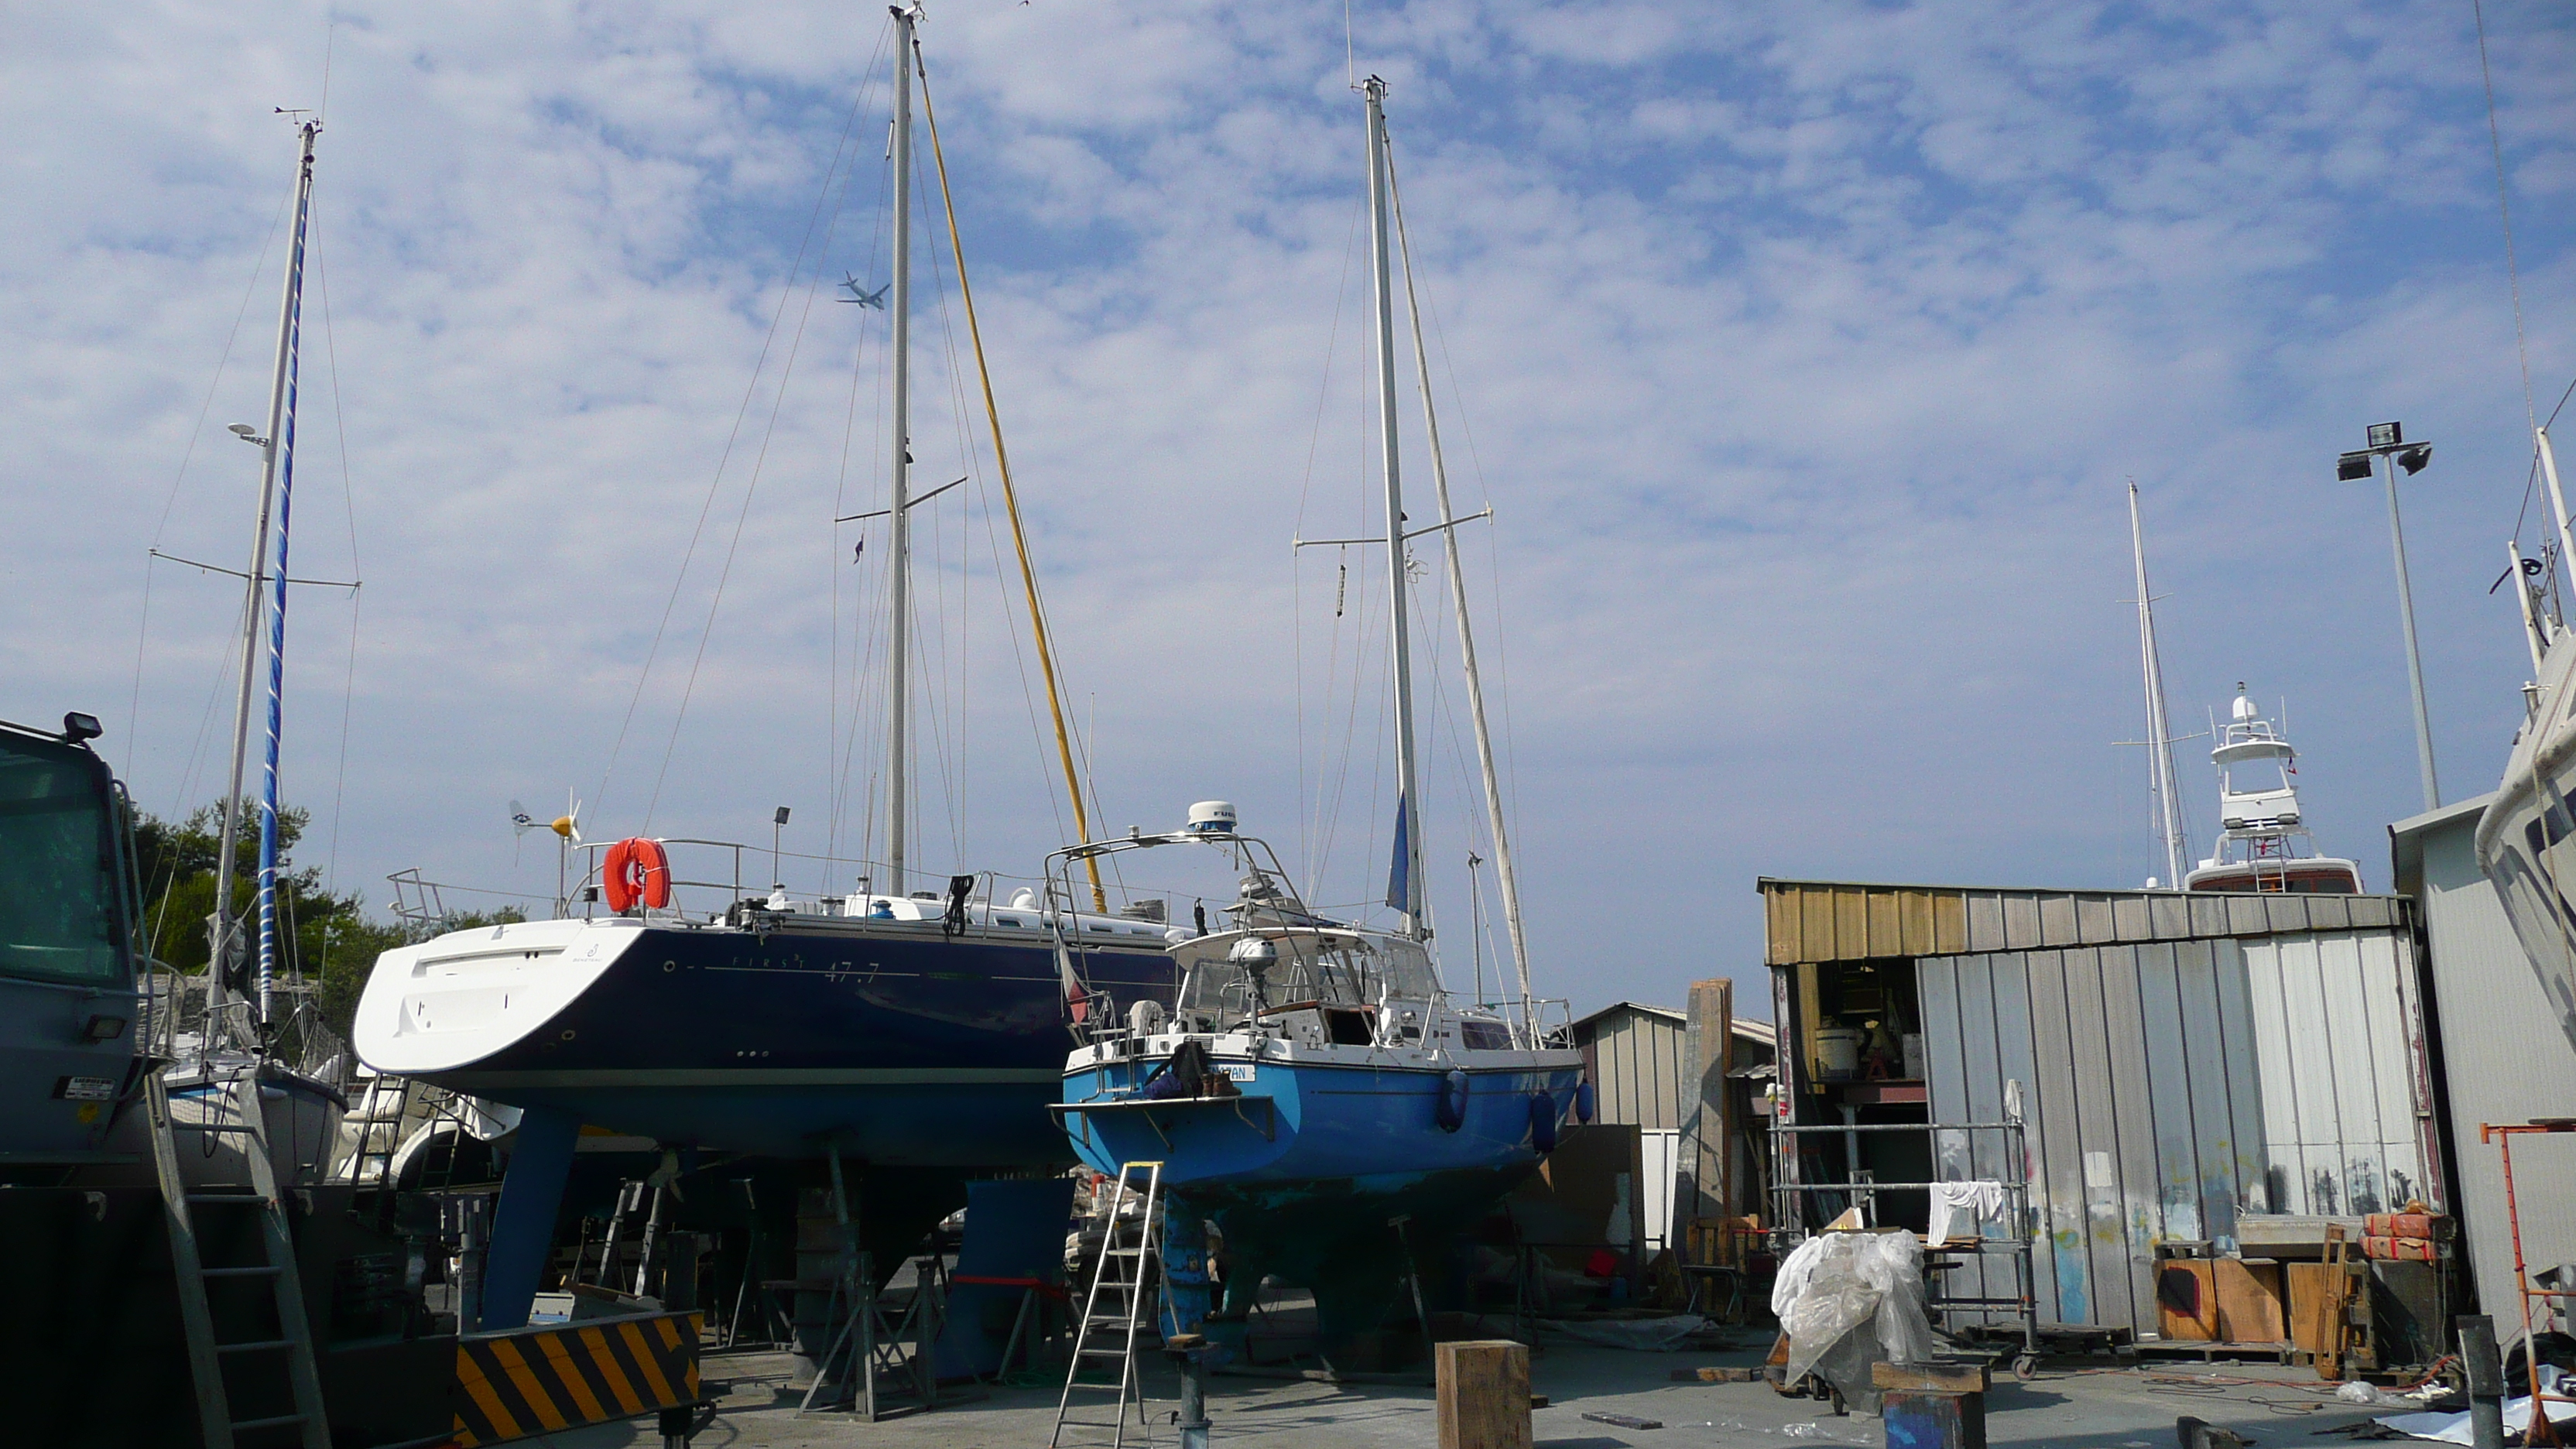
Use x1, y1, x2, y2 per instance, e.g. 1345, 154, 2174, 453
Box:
0, 738, 126, 982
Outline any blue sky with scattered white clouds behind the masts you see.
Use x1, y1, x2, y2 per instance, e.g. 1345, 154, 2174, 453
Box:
0, 0, 2576, 1011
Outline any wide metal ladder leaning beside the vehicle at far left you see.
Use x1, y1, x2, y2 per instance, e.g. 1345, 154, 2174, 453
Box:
144, 1070, 330, 1449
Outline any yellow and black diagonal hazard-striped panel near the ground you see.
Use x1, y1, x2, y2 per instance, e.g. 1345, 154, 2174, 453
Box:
454, 1312, 701, 1447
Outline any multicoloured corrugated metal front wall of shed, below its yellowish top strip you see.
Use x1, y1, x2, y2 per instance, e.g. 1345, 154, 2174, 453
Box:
1917, 923, 2424, 1331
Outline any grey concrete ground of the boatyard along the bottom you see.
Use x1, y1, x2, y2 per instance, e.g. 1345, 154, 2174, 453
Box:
526, 1341, 2390, 1449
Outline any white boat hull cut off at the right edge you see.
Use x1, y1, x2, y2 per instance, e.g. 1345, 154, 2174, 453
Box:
2478, 637, 2576, 1050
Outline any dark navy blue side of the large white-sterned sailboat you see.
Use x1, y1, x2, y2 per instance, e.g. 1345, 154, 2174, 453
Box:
423, 928, 1175, 1168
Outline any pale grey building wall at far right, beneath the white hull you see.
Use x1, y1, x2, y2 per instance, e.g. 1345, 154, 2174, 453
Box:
2396, 800, 2576, 1331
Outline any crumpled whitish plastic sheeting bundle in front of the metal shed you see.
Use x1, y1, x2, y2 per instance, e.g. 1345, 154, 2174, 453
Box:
1773, 1228, 1934, 1408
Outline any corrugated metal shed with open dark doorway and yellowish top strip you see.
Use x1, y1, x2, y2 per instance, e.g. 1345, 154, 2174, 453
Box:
1759, 879, 2448, 1333
